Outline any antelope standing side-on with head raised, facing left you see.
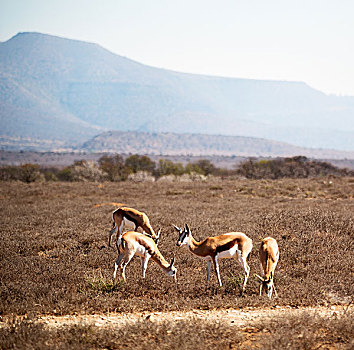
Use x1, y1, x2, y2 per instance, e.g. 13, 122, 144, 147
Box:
173, 224, 252, 293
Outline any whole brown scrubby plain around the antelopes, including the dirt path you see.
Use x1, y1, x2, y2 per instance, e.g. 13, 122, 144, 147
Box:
0, 176, 354, 349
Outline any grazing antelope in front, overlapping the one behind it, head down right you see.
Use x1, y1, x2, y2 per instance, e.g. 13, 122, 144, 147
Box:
113, 231, 177, 281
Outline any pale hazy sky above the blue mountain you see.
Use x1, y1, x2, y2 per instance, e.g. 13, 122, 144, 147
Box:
0, 0, 354, 96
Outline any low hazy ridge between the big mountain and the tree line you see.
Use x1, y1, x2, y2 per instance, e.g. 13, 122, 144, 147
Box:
80, 131, 354, 159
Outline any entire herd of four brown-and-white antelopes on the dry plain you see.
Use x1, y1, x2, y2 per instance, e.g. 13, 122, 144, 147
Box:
108, 207, 279, 298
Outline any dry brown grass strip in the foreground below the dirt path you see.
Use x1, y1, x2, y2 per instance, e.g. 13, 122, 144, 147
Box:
0, 312, 354, 350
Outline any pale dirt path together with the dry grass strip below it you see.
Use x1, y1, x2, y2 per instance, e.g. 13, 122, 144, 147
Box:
0, 306, 354, 350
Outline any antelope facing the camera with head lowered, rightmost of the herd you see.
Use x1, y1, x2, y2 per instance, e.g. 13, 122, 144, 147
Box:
256, 237, 279, 299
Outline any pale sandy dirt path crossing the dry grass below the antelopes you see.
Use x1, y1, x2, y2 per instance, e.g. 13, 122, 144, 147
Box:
27, 306, 346, 327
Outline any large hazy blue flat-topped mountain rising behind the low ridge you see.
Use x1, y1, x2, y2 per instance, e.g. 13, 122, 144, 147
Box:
0, 33, 354, 150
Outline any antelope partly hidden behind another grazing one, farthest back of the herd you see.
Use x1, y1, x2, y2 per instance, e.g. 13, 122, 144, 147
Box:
108, 207, 160, 249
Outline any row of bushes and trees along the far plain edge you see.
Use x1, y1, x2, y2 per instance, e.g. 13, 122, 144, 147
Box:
0, 154, 354, 183
